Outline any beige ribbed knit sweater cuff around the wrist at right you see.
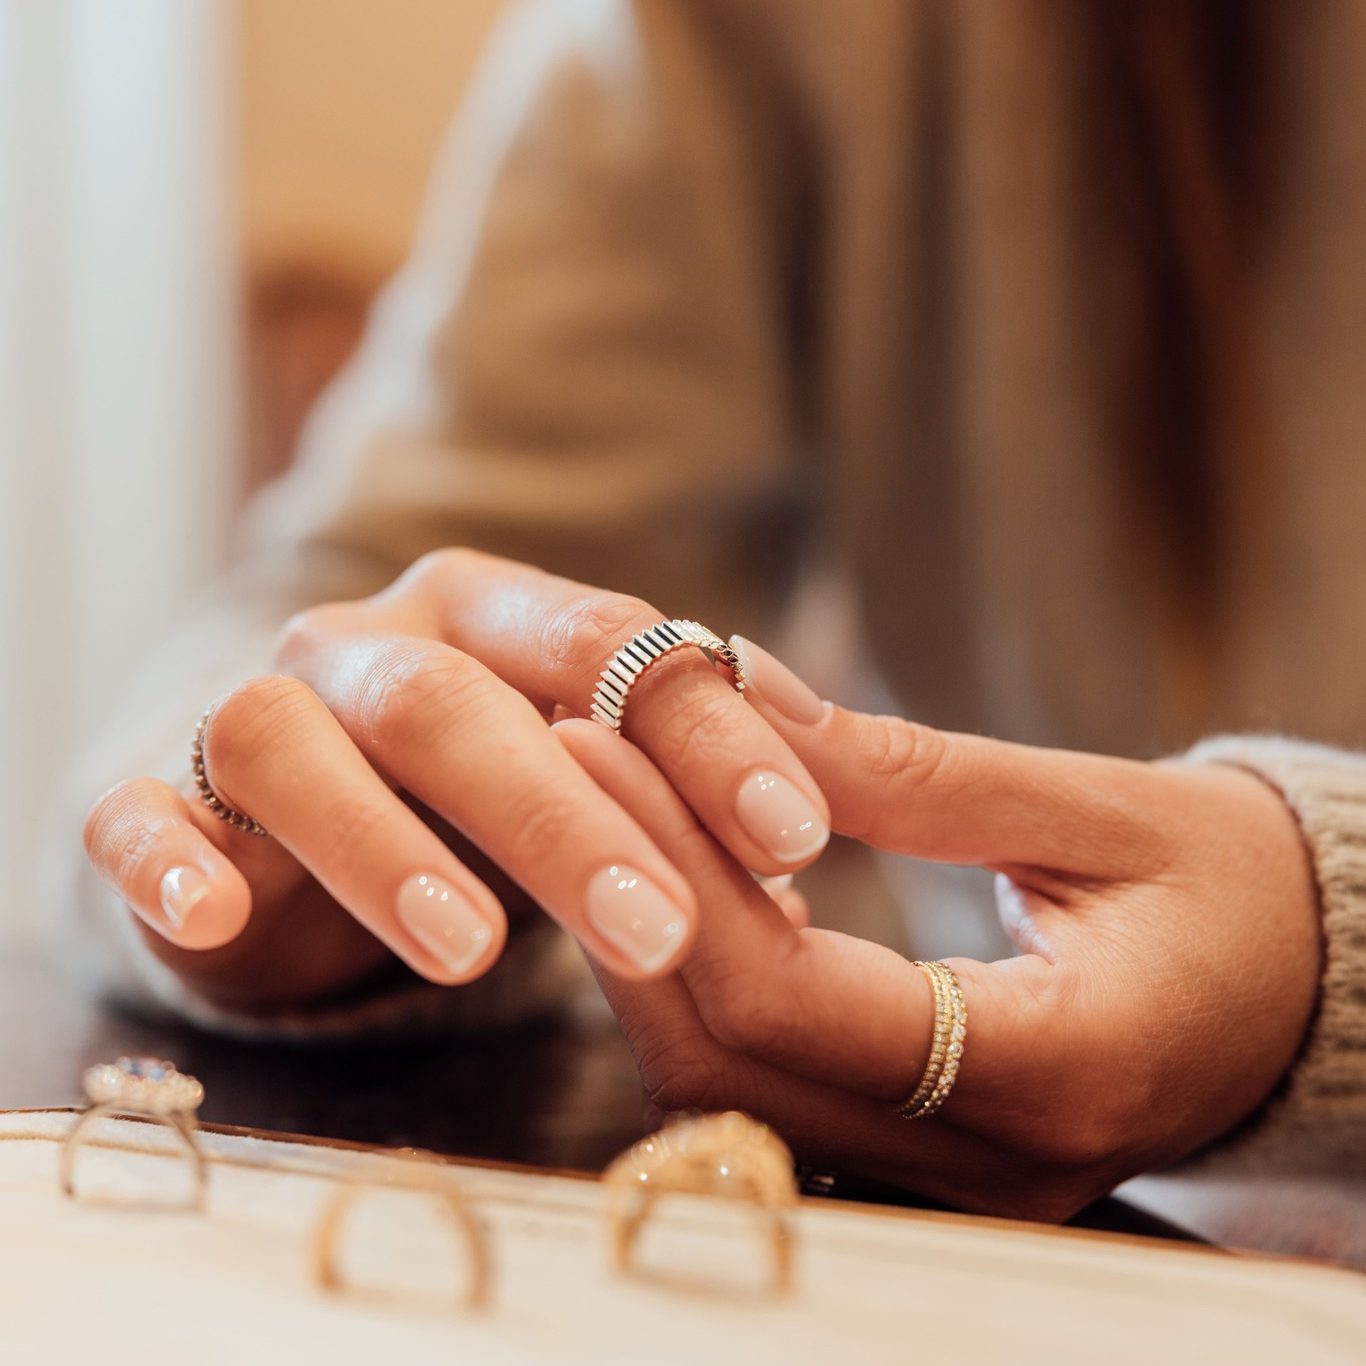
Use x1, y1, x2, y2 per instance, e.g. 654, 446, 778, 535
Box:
1187, 736, 1366, 1176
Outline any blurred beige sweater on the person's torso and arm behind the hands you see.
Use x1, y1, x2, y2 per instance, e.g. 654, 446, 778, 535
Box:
58, 0, 1366, 1174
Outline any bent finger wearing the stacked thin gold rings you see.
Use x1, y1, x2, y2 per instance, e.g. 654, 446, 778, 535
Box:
555, 721, 1071, 1127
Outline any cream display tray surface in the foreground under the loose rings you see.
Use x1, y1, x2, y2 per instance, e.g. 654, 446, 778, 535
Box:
0, 1111, 1366, 1366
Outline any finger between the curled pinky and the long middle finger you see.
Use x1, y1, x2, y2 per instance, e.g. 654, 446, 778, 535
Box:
204, 678, 507, 985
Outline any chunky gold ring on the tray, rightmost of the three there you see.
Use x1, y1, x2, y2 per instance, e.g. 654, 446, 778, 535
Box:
602, 1111, 796, 1294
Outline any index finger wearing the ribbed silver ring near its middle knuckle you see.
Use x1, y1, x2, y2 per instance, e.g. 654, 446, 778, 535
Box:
352, 550, 829, 873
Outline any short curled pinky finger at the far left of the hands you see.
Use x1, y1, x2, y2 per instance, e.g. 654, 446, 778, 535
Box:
85, 779, 251, 949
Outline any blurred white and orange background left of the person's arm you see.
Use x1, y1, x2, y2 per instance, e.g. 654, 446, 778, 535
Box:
0, 0, 501, 929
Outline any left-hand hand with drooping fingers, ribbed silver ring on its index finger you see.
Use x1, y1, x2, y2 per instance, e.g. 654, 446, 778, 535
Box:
86, 550, 829, 1005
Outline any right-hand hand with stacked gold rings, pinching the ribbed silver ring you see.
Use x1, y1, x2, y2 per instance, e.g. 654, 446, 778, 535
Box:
556, 646, 1320, 1218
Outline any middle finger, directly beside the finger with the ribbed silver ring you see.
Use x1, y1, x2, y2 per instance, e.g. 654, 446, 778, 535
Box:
282, 634, 697, 977
